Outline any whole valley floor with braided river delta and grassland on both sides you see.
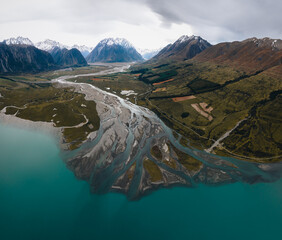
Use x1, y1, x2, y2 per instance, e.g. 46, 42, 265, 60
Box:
0, 59, 281, 200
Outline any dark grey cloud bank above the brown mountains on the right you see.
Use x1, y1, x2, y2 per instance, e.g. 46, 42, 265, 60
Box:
141, 0, 282, 42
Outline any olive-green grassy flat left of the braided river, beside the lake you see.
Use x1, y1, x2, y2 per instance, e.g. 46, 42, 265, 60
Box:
0, 76, 100, 150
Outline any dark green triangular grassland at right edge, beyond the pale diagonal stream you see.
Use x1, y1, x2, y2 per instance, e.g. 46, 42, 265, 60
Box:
217, 95, 282, 162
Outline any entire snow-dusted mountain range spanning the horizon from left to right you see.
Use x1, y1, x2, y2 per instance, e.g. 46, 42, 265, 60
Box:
0, 35, 282, 73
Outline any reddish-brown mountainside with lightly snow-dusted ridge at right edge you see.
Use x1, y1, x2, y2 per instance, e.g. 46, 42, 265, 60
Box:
193, 38, 282, 73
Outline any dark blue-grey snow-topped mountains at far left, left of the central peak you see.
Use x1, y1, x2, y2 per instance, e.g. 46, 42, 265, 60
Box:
0, 37, 87, 73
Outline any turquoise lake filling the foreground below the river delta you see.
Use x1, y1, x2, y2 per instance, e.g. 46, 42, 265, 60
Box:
0, 124, 282, 240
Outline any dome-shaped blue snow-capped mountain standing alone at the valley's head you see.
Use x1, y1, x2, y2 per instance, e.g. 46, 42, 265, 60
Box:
86, 38, 143, 62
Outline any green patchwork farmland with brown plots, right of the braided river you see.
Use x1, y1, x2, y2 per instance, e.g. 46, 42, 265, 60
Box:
129, 60, 282, 161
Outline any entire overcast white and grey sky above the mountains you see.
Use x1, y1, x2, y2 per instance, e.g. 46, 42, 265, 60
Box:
0, 0, 282, 49
